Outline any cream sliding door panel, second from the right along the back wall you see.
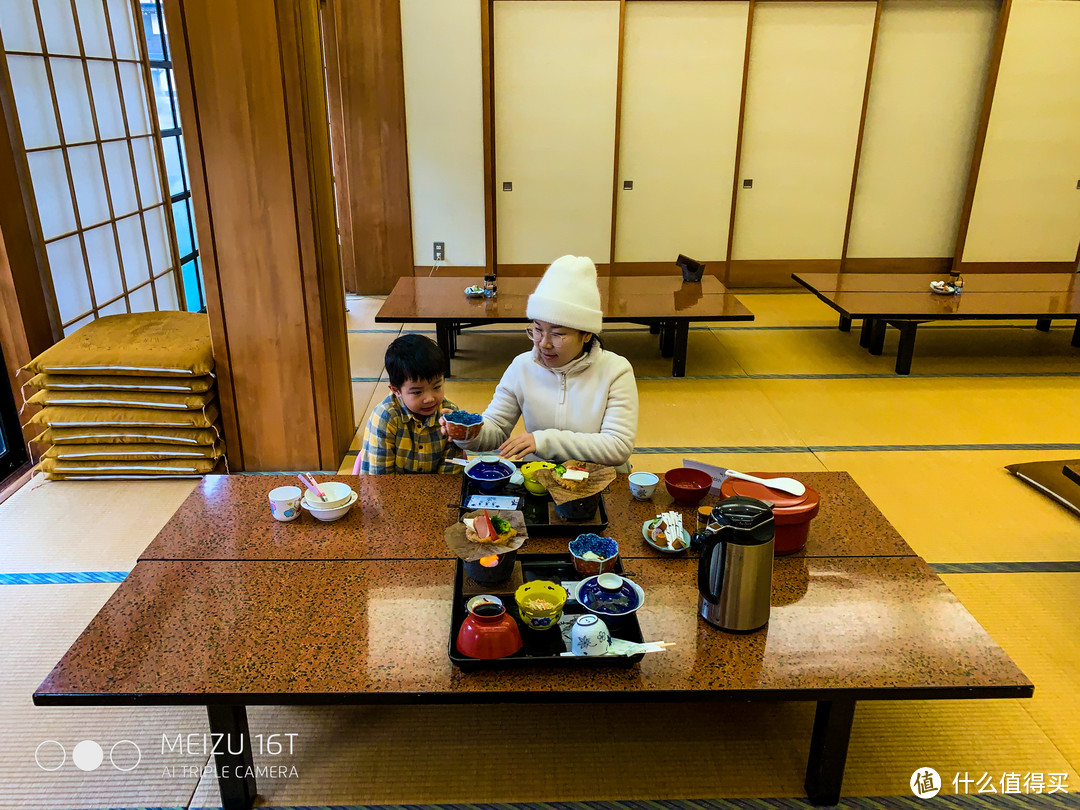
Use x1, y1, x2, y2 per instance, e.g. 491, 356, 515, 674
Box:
848, 0, 998, 258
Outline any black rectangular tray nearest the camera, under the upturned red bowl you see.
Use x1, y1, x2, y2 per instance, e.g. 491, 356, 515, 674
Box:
447, 554, 645, 672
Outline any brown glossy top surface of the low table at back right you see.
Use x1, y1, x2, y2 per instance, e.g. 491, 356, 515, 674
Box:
793, 272, 1080, 295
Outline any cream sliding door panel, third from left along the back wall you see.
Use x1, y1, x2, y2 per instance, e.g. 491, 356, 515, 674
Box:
732, 2, 876, 259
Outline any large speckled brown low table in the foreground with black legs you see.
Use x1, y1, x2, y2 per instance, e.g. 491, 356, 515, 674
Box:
33, 473, 1034, 810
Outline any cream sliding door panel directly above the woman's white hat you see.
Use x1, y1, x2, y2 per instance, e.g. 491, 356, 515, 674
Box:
494, 0, 619, 265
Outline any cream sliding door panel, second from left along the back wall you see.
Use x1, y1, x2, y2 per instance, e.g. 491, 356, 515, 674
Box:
615, 1, 750, 261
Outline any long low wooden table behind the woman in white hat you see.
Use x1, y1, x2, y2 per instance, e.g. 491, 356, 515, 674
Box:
375, 275, 754, 377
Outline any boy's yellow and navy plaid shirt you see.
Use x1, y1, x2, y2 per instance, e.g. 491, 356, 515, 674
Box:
360, 394, 462, 475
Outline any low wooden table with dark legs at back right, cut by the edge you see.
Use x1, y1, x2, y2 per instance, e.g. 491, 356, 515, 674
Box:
792, 273, 1080, 374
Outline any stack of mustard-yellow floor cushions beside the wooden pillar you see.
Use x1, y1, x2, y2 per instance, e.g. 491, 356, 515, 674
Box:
26, 312, 225, 480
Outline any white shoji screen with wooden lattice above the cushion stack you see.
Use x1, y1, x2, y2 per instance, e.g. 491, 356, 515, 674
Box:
0, 0, 179, 334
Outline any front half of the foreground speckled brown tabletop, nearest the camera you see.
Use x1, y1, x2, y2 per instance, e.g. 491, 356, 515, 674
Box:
36, 557, 1031, 704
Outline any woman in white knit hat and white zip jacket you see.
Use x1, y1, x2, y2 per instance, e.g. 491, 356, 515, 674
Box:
442, 256, 637, 472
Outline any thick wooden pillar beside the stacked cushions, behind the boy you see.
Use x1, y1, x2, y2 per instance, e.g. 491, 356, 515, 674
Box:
165, 0, 354, 471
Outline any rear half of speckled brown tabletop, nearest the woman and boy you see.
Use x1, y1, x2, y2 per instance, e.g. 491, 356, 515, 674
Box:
139, 472, 915, 561
